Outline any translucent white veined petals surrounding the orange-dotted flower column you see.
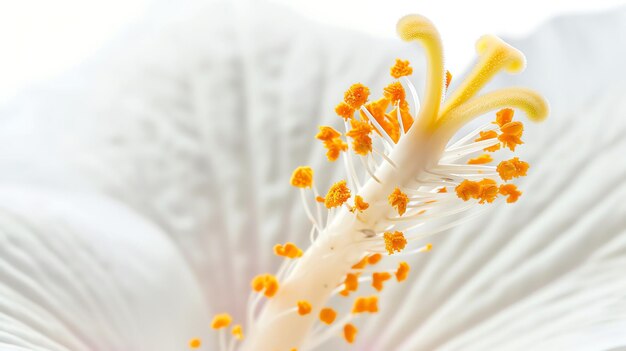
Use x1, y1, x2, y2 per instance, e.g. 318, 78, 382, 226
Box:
0, 3, 626, 351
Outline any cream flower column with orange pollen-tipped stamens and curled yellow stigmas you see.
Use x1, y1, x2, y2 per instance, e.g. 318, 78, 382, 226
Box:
190, 15, 548, 351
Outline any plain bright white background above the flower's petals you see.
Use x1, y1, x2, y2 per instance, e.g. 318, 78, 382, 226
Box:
0, 0, 626, 104
